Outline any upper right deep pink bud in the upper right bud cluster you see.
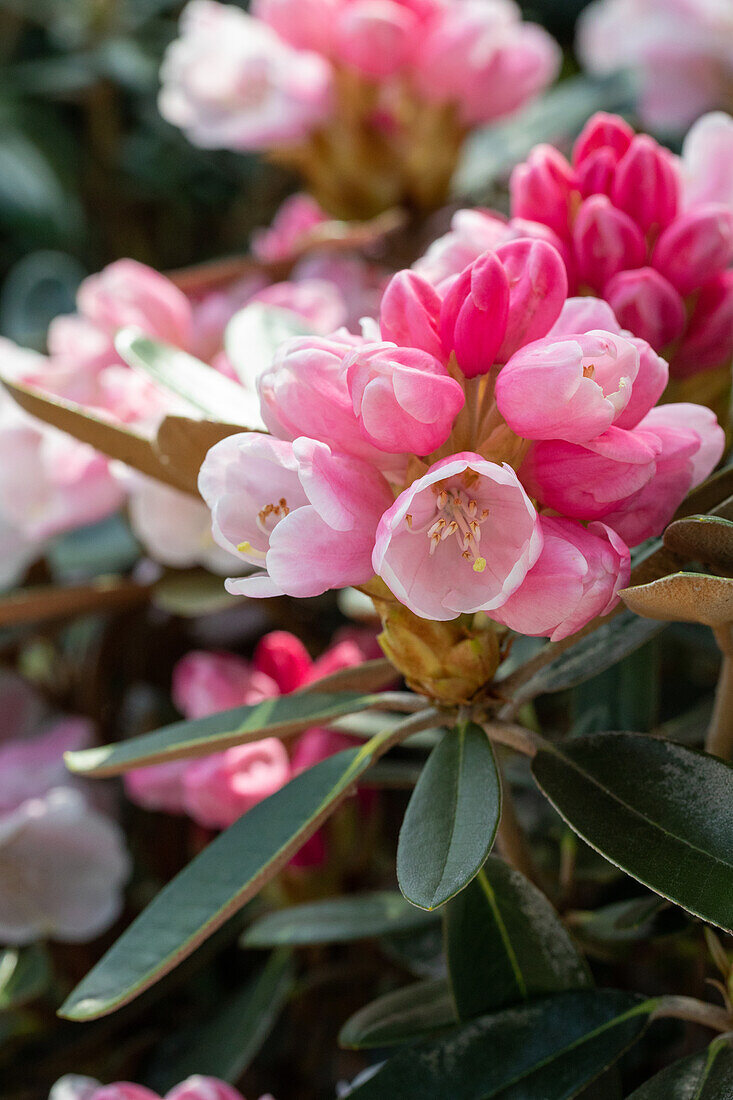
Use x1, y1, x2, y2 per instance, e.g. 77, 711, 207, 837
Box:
611, 134, 679, 233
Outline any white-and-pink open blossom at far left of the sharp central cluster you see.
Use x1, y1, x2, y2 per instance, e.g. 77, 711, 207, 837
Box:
199, 432, 392, 596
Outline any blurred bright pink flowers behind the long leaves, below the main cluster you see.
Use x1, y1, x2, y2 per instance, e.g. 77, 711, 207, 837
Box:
125, 630, 365, 864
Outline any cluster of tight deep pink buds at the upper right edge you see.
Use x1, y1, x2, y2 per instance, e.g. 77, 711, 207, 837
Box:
511, 112, 733, 376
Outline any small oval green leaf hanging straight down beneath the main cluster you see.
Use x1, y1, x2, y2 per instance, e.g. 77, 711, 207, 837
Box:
397, 723, 502, 909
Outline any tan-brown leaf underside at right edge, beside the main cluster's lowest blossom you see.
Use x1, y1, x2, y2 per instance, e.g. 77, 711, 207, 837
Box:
620, 573, 733, 627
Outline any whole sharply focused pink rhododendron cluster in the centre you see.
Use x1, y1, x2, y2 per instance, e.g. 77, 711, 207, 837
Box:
199, 237, 724, 638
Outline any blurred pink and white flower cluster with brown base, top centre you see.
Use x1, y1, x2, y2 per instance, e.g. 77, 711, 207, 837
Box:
160, 0, 560, 217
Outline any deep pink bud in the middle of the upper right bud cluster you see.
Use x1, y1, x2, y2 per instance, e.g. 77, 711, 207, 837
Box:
572, 195, 646, 290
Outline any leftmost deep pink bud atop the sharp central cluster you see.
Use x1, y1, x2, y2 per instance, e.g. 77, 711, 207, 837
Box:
380, 271, 442, 359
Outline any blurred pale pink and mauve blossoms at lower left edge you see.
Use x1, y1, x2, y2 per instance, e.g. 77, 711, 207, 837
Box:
0, 675, 130, 944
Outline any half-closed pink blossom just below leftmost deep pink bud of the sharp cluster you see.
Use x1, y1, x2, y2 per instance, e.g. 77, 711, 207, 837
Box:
343, 343, 464, 454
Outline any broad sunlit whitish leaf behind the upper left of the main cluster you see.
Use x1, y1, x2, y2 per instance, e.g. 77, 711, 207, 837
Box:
225, 301, 314, 393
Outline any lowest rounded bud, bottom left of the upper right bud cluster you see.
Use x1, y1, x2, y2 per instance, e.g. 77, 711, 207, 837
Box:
604, 267, 686, 351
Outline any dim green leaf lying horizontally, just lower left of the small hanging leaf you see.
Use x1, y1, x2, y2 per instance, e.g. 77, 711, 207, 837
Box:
242, 890, 438, 947
